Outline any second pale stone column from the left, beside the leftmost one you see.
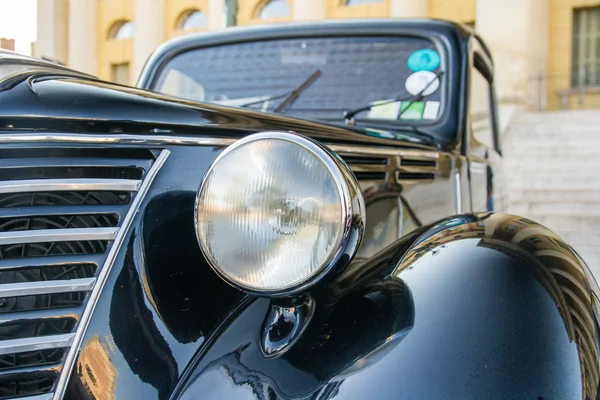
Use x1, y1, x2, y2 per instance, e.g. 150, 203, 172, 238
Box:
68, 0, 98, 75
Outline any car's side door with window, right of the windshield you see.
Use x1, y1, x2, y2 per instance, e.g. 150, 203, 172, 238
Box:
466, 43, 504, 212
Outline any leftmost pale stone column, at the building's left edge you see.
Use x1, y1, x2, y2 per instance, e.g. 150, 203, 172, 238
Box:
33, 0, 69, 64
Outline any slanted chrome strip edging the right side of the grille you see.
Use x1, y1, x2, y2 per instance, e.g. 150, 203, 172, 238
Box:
53, 149, 171, 400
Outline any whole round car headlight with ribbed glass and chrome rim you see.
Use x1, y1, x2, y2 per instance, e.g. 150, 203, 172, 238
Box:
195, 132, 365, 296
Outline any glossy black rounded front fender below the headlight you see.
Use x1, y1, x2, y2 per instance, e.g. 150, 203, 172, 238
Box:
173, 213, 600, 400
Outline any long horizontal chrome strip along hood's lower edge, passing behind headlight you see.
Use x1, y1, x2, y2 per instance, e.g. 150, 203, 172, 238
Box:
0, 133, 438, 160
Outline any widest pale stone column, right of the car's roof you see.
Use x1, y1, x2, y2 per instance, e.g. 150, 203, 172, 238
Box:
475, 0, 548, 107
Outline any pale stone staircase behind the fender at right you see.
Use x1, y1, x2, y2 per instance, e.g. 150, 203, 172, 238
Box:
503, 110, 600, 279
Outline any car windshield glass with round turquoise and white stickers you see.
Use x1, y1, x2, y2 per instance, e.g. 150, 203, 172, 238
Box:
152, 36, 448, 123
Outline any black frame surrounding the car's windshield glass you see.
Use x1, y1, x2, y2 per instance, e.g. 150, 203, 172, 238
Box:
138, 19, 472, 143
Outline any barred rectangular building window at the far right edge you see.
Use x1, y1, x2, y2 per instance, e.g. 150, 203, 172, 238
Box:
571, 7, 600, 87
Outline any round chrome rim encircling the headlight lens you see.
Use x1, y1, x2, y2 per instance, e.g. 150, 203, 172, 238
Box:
194, 131, 365, 298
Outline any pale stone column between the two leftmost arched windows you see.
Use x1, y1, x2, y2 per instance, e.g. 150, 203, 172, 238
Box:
133, 0, 166, 82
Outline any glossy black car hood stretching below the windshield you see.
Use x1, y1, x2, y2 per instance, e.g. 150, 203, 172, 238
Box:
0, 70, 443, 148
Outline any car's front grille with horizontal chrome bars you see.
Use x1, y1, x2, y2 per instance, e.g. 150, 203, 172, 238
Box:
0, 147, 162, 399
